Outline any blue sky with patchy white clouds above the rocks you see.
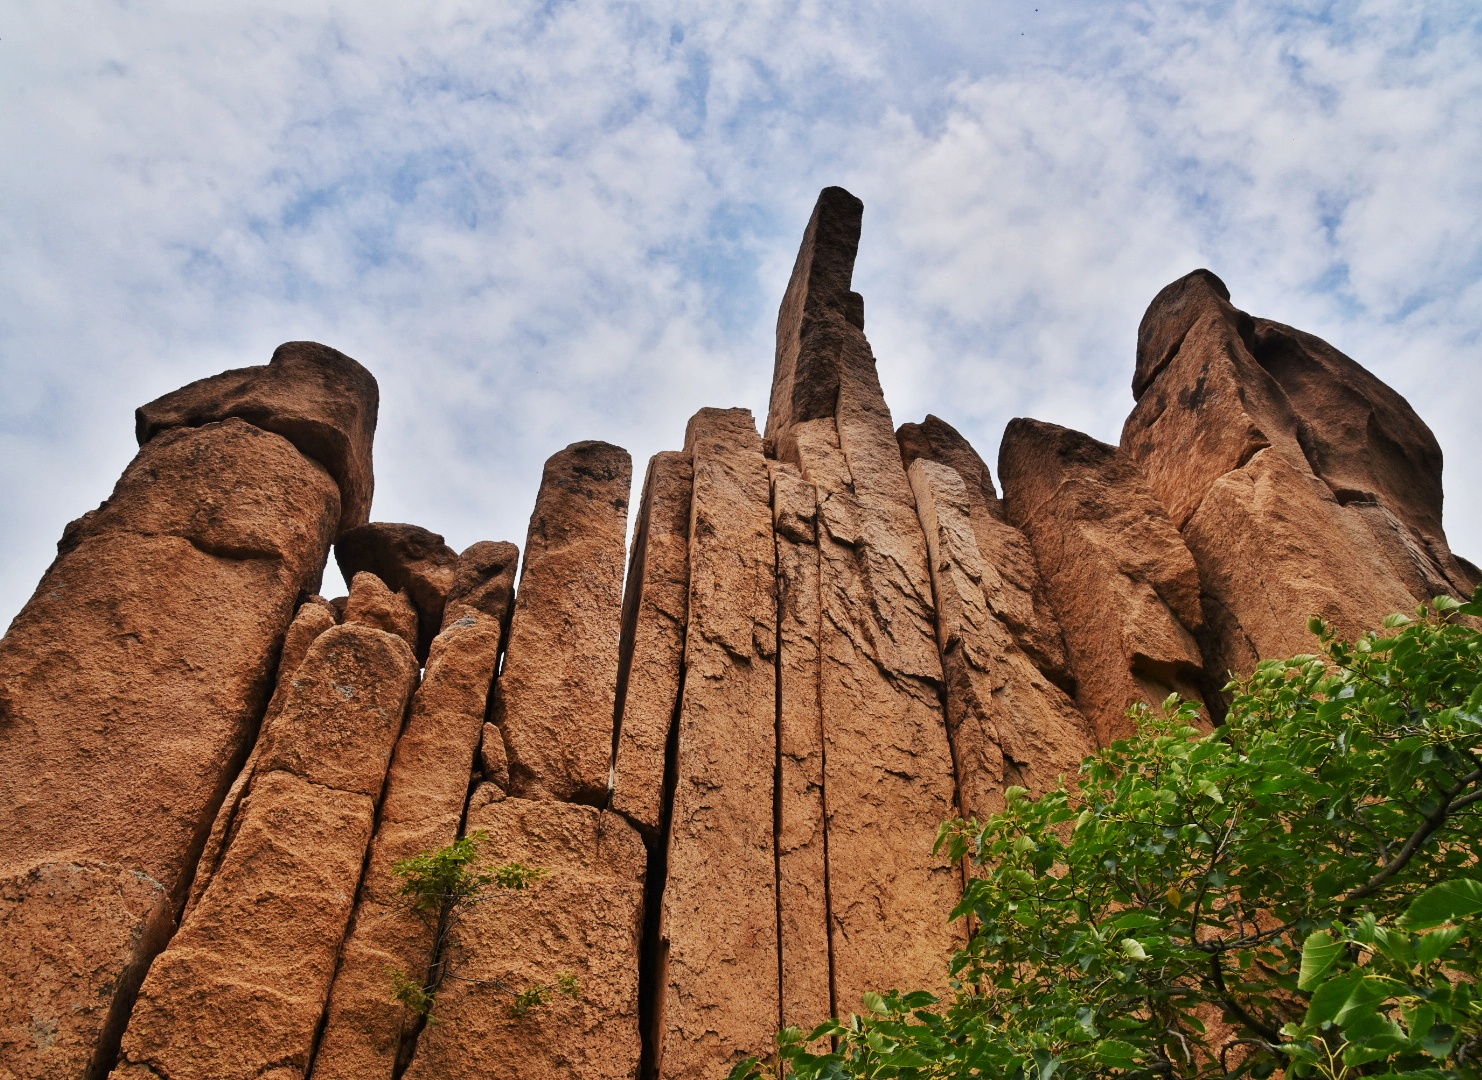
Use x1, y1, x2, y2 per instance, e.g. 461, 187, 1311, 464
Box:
0, 0, 1482, 625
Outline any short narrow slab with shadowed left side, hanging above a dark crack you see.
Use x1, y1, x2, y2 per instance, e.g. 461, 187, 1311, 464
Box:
612, 452, 695, 836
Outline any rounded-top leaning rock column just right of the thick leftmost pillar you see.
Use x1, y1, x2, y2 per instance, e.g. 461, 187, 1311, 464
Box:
114, 625, 416, 1080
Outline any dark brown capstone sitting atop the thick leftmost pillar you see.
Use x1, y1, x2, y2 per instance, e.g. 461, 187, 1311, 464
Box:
135, 341, 381, 535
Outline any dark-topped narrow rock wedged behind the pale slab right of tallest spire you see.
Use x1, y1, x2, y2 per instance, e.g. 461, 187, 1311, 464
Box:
895, 415, 1076, 695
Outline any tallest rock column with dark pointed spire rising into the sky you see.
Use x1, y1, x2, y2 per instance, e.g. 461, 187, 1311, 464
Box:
766, 188, 960, 1012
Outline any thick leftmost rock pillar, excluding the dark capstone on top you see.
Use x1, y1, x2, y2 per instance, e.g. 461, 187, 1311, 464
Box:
0, 419, 339, 1079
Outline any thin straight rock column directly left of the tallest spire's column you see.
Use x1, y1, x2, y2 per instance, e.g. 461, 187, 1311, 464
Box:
769, 462, 834, 1031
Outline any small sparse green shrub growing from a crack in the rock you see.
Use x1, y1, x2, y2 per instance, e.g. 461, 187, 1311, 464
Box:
387, 830, 554, 1022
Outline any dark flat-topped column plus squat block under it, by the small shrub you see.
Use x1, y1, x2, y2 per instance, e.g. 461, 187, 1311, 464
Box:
403, 443, 646, 1080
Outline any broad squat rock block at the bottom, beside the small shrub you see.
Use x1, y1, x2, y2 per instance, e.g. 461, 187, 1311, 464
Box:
403, 796, 645, 1080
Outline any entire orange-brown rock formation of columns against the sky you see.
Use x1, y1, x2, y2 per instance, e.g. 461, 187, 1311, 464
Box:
0, 188, 1479, 1080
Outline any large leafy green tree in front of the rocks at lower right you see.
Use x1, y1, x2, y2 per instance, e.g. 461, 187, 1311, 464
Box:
732, 591, 1482, 1080
